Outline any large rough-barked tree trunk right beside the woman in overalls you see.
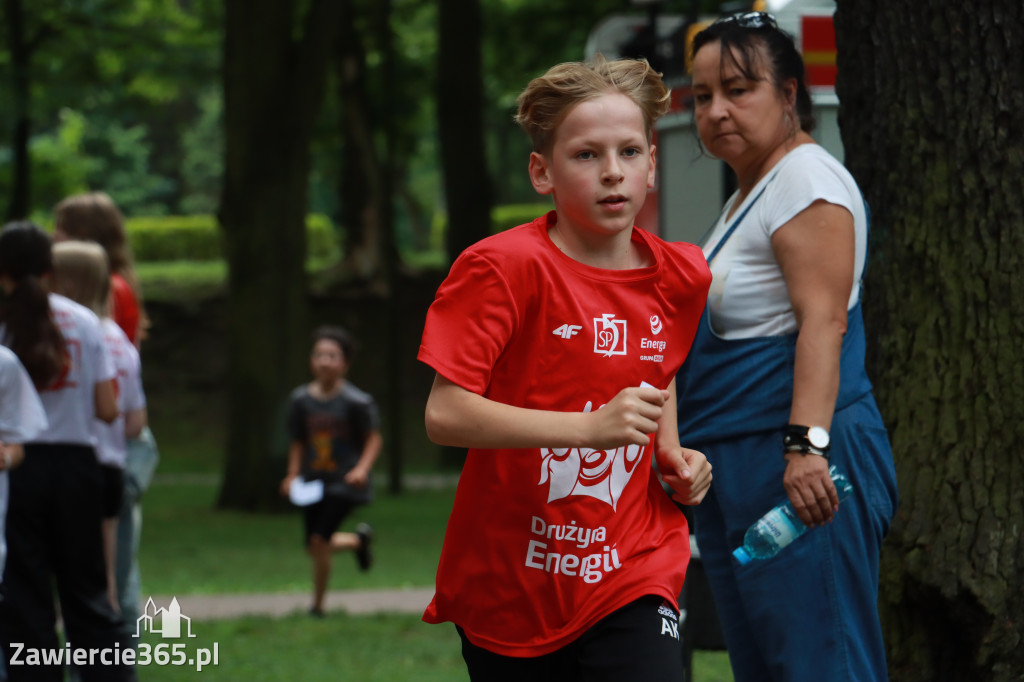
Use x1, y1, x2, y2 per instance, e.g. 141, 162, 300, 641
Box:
836, 0, 1024, 682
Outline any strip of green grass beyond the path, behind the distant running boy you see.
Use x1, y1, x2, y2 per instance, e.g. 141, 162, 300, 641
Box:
139, 483, 454, 595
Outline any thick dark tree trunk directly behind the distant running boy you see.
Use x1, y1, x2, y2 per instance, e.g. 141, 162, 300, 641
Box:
219, 0, 340, 509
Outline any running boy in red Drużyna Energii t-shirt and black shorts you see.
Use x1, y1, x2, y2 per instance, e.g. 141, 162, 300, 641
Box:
419, 56, 711, 682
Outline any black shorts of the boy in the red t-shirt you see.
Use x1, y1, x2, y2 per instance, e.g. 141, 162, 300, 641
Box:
458, 595, 683, 682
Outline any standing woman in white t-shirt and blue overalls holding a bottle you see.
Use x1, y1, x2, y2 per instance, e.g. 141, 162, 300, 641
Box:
678, 12, 896, 682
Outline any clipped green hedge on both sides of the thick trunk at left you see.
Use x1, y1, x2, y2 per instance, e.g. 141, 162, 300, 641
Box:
125, 213, 340, 262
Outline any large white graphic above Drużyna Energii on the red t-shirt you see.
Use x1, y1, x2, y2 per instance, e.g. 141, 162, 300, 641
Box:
538, 401, 644, 509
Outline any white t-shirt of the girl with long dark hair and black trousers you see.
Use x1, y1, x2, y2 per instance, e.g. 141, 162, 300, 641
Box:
34, 294, 116, 445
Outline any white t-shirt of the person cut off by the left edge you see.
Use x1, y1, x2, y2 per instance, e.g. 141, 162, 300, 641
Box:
0, 346, 46, 578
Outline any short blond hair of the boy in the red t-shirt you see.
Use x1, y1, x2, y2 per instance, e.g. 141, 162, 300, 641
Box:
515, 53, 670, 154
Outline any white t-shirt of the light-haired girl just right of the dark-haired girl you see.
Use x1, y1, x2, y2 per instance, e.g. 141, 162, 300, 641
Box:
93, 317, 145, 469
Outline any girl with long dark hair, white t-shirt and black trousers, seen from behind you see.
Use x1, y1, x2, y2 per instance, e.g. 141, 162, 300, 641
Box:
0, 222, 135, 682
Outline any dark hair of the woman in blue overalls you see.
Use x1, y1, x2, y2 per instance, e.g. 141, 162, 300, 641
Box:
691, 15, 814, 132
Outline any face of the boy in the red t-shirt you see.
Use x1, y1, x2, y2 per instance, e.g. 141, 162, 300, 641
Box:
529, 93, 654, 238
